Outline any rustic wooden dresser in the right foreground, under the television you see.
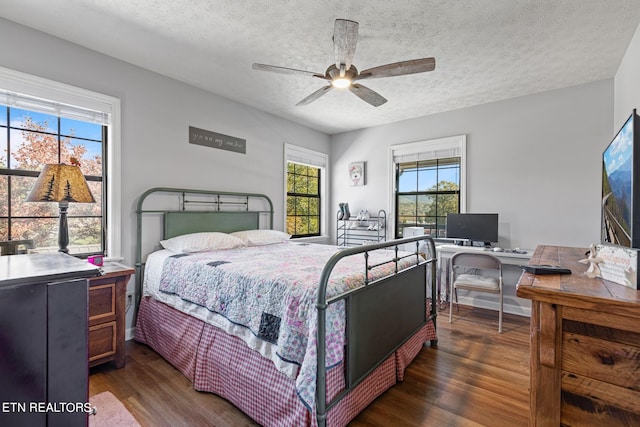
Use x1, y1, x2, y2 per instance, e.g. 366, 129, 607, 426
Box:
517, 246, 640, 427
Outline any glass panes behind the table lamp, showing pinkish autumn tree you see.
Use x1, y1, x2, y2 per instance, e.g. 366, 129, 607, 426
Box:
0, 105, 107, 254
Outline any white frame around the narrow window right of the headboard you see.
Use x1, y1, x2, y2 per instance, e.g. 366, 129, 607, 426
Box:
282, 143, 329, 241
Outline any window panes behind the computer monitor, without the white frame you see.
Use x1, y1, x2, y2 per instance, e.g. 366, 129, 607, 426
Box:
396, 157, 460, 237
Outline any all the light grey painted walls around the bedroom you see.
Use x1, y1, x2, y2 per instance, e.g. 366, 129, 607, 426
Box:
0, 11, 640, 323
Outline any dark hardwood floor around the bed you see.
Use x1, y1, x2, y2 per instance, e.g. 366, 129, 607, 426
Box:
89, 306, 529, 427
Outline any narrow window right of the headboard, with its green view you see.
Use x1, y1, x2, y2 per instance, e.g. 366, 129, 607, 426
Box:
285, 144, 328, 238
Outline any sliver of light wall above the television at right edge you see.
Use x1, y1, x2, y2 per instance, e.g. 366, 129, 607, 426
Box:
612, 20, 640, 127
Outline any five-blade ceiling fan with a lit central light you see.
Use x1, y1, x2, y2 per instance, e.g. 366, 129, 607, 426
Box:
252, 19, 436, 107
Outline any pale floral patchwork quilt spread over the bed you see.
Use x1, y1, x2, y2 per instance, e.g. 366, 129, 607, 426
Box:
159, 242, 416, 410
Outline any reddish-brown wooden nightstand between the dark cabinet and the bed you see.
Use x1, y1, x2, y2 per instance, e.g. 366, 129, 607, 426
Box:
89, 262, 135, 368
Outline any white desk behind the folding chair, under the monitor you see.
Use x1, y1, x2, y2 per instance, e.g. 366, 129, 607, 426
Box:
436, 244, 533, 316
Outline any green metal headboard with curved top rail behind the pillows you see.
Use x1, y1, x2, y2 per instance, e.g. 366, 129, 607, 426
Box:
135, 187, 273, 311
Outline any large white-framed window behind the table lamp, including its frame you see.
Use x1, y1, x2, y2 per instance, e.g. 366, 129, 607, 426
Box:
0, 67, 122, 260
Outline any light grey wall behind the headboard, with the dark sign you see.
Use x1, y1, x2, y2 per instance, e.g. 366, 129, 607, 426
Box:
0, 19, 330, 334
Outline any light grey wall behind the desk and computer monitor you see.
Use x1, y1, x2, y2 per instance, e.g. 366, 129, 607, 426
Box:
331, 80, 613, 248
